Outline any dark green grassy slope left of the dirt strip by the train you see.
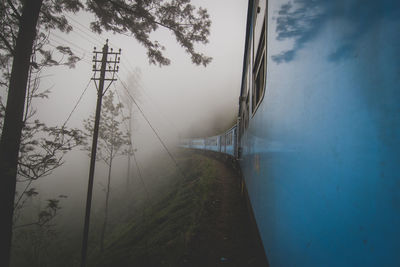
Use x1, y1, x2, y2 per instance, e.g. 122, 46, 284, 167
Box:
90, 154, 215, 267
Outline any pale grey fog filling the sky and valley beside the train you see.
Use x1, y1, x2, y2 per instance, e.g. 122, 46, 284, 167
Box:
7, 0, 247, 266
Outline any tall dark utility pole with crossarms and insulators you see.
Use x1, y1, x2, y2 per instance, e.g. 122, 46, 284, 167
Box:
81, 39, 121, 267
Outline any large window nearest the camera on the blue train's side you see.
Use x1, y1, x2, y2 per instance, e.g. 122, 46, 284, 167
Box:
251, 20, 266, 114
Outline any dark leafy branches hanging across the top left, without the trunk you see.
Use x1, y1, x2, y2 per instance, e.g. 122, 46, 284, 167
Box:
0, 0, 211, 86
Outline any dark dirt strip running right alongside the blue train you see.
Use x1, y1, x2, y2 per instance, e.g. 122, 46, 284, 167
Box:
182, 153, 268, 267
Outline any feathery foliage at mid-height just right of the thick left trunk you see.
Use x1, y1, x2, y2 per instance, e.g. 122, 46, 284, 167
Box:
0, 68, 84, 184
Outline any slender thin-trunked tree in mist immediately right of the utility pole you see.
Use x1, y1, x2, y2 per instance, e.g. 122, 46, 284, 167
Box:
84, 91, 132, 252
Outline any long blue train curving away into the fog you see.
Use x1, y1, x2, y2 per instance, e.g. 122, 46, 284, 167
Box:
182, 0, 400, 266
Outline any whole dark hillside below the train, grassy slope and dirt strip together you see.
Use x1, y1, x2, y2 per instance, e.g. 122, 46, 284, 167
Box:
90, 152, 267, 267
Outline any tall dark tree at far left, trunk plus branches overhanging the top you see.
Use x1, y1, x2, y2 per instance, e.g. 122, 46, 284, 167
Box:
0, 0, 211, 266
